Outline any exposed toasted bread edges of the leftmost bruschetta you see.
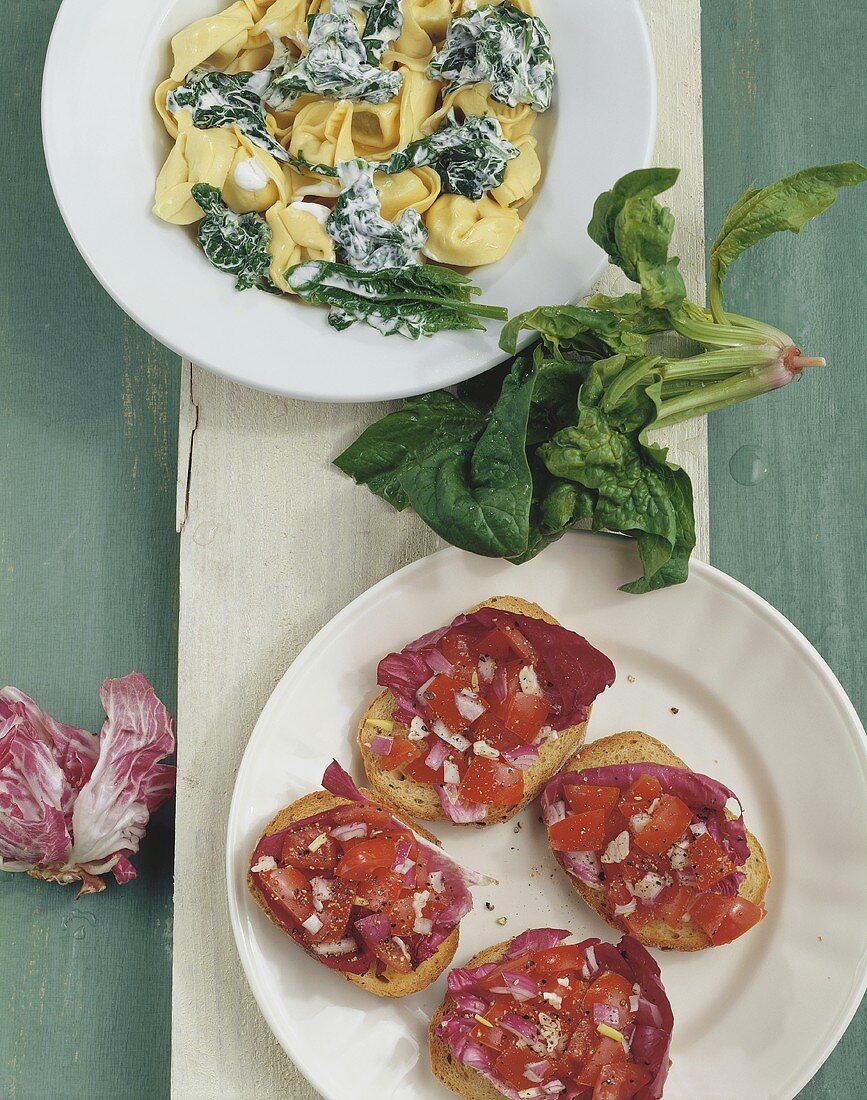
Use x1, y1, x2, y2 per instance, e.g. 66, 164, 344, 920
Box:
246, 788, 460, 997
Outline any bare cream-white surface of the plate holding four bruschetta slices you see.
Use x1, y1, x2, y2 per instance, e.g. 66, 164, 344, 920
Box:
227, 534, 867, 1100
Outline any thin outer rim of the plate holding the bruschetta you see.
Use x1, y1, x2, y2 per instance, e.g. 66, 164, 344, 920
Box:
226, 531, 867, 1100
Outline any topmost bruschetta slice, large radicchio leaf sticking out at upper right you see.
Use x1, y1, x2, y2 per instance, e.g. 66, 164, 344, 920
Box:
358, 596, 614, 825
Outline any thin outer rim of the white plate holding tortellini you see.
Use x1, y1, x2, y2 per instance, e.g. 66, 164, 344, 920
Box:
40, 0, 659, 405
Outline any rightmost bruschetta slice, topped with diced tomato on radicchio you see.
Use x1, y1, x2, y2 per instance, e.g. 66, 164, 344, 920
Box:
541, 732, 770, 952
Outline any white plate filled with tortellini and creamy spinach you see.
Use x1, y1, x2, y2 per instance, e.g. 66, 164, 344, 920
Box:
42, 0, 656, 402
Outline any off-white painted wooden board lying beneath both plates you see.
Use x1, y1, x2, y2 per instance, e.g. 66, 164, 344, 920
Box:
172, 0, 707, 1100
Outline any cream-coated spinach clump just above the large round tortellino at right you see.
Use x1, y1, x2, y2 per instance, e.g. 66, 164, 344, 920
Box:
376, 113, 520, 199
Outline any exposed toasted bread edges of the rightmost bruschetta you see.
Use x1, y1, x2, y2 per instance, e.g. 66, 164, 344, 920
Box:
563, 730, 770, 952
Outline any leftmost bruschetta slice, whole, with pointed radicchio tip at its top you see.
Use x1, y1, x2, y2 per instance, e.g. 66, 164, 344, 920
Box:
248, 761, 490, 997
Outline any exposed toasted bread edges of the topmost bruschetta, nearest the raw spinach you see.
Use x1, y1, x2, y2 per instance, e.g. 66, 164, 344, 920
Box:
358, 596, 591, 825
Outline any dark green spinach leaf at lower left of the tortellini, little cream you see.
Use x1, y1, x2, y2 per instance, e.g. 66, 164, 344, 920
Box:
193, 184, 271, 290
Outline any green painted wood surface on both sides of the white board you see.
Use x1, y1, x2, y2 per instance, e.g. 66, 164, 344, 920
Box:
0, 0, 867, 1100
